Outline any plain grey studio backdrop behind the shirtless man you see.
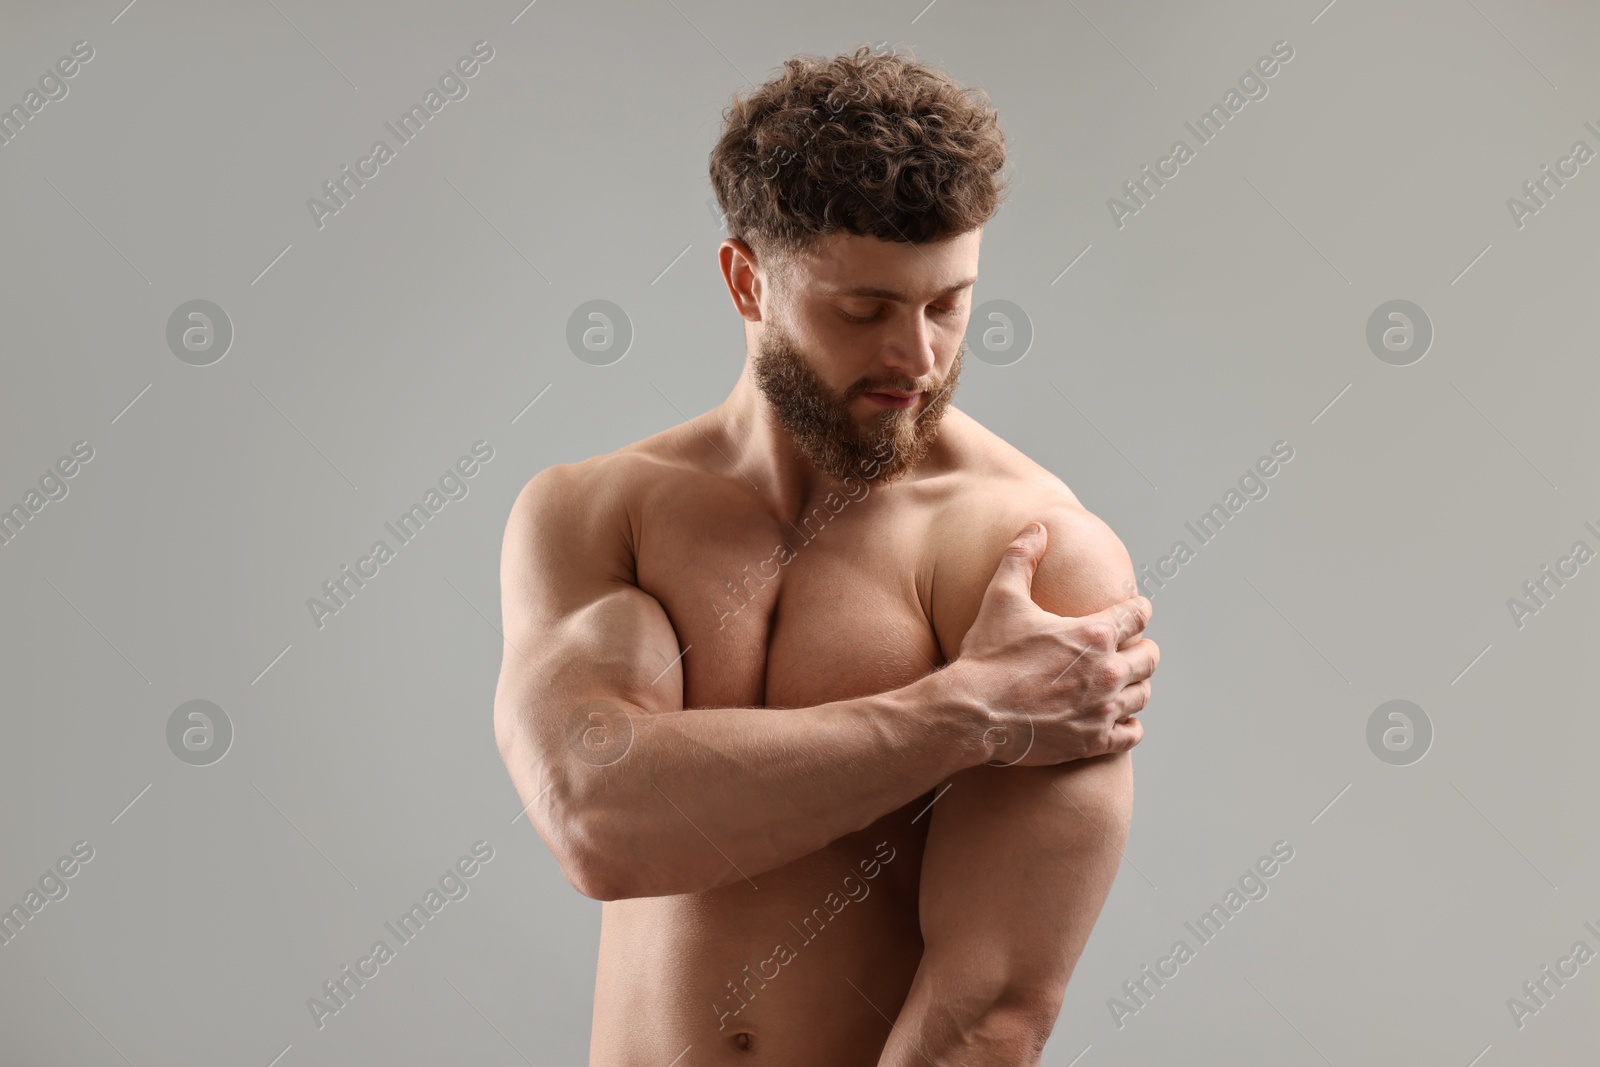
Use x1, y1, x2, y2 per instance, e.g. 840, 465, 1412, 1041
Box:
0, 0, 1600, 1067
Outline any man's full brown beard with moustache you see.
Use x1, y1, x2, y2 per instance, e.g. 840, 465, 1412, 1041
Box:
752, 322, 966, 485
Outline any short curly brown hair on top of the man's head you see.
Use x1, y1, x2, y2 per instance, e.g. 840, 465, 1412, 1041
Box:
710, 45, 1006, 279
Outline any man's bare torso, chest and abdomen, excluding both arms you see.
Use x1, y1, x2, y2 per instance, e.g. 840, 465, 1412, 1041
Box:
590, 408, 1072, 1067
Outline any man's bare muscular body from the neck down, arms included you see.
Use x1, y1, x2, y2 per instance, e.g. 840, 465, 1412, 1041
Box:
496, 225, 1155, 1067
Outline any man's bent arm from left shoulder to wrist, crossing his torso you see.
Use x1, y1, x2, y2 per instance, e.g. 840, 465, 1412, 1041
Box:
494, 466, 1142, 901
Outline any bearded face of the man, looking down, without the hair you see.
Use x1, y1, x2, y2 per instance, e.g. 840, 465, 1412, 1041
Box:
752, 230, 982, 483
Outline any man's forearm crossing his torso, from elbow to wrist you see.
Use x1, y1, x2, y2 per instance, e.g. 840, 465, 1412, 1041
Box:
507, 664, 989, 899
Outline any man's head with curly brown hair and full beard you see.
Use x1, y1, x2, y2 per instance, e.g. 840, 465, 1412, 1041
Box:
710, 48, 1005, 482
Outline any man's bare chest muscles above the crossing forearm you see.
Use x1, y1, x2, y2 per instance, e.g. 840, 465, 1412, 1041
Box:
637, 491, 942, 707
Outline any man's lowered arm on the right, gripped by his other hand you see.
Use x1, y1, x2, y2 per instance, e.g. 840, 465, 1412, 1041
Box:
878, 507, 1138, 1067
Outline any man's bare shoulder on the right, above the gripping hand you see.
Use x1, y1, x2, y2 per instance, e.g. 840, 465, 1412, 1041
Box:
931, 418, 1138, 656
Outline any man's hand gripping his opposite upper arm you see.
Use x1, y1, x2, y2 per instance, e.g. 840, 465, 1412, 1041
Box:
946, 523, 1160, 766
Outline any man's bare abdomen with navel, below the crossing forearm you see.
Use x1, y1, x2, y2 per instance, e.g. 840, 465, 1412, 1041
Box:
590, 793, 933, 1067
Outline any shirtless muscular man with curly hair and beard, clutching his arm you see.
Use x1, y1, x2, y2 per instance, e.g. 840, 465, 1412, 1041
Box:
494, 50, 1158, 1067
